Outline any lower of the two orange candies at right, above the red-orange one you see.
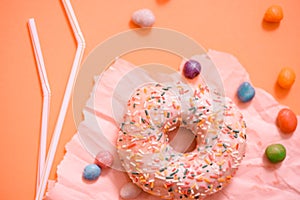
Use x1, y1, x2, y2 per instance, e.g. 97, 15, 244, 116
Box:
277, 67, 296, 89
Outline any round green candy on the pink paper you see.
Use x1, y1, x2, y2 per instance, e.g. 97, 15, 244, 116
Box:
265, 144, 286, 163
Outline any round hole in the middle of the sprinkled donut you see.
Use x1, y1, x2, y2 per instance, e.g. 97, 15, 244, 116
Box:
167, 127, 197, 153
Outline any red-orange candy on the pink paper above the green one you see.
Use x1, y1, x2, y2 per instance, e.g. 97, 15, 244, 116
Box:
277, 108, 298, 133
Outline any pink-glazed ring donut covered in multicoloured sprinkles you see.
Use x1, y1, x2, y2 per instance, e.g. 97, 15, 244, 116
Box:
117, 82, 246, 199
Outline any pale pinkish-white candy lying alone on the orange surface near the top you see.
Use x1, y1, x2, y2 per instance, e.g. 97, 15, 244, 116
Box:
131, 9, 155, 27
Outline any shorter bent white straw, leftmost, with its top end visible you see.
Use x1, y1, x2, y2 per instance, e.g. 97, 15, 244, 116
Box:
28, 18, 51, 194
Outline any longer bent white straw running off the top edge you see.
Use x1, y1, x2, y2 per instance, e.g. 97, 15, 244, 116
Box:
35, 0, 85, 200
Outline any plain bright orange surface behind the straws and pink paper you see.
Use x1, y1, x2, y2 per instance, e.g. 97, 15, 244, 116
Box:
0, 0, 300, 200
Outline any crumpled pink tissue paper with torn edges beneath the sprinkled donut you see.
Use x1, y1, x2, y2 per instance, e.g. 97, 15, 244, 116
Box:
45, 50, 300, 200
